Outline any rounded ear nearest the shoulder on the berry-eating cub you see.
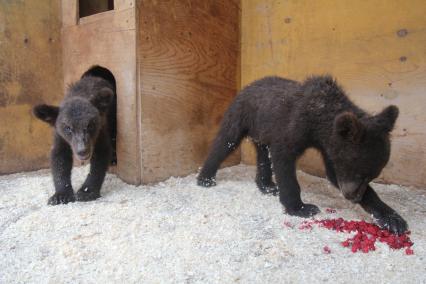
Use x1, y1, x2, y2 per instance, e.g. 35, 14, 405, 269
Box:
333, 112, 364, 143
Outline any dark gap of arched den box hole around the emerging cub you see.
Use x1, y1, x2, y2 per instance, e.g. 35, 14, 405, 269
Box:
83, 65, 117, 165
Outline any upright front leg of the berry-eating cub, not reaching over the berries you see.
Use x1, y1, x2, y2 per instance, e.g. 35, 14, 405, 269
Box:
271, 150, 320, 218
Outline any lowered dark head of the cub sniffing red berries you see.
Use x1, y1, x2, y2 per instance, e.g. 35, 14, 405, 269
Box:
329, 106, 399, 202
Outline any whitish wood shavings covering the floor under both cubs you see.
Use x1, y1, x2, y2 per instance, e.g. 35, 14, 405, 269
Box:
0, 165, 426, 283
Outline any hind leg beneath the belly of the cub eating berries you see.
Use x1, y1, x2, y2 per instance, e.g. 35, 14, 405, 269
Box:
255, 143, 278, 195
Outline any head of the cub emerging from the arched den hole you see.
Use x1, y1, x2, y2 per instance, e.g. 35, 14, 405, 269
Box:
33, 77, 114, 161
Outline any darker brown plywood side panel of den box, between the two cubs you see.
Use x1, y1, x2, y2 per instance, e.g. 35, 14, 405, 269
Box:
137, 0, 240, 183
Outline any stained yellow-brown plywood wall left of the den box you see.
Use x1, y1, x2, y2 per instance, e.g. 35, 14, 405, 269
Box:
0, 0, 63, 174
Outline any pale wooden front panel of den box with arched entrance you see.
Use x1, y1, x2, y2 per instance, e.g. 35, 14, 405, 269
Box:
62, 0, 141, 184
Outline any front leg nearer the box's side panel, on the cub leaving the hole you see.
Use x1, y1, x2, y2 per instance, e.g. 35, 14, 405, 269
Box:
76, 131, 112, 201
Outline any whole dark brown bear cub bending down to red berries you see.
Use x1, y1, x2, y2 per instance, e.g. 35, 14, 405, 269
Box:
198, 76, 407, 233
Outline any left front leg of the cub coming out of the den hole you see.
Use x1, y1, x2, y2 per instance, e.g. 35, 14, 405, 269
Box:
47, 135, 75, 205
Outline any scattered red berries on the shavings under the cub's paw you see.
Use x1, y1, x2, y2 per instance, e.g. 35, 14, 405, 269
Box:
299, 218, 414, 255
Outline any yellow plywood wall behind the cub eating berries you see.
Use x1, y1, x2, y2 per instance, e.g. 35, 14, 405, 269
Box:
241, 0, 426, 187
